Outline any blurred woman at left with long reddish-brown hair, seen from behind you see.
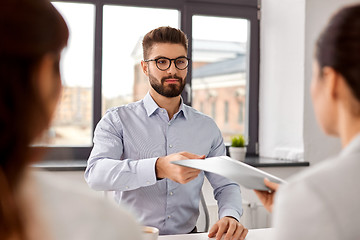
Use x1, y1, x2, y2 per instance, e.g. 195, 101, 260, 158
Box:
0, 0, 140, 240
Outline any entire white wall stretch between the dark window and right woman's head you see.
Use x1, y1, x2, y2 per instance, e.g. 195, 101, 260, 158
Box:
259, 0, 360, 165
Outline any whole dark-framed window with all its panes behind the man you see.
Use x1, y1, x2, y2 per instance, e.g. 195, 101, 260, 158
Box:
42, 0, 259, 160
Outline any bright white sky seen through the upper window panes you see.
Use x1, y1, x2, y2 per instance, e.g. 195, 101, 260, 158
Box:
53, 2, 248, 97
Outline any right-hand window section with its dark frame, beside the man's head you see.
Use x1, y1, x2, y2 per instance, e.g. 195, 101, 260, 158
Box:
191, 7, 258, 154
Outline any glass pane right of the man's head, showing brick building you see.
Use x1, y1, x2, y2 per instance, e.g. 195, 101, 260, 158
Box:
192, 15, 249, 143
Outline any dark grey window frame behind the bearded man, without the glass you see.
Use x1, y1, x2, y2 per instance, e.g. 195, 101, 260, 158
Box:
45, 0, 259, 160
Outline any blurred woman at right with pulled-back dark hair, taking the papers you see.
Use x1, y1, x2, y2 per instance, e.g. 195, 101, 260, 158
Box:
255, 5, 360, 240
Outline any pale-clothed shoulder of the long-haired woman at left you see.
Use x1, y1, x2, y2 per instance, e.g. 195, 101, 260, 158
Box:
33, 171, 141, 240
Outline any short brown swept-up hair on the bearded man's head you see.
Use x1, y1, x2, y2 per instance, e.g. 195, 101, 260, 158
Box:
142, 27, 188, 59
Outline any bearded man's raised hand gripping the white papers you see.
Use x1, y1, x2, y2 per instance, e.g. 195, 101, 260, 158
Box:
155, 152, 205, 184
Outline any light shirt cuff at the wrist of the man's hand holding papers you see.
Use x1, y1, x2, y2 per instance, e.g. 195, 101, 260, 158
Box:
137, 157, 158, 187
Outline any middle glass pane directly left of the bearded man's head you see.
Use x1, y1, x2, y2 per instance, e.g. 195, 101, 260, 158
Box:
102, 5, 179, 114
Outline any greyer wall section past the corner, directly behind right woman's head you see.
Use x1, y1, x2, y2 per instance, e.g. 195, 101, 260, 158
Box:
303, 0, 360, 164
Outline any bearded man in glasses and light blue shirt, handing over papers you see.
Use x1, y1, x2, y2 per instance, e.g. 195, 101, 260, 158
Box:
85, 27, 248, 239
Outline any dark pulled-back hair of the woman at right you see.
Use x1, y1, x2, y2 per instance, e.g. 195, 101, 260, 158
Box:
316, 5, 360, 102
